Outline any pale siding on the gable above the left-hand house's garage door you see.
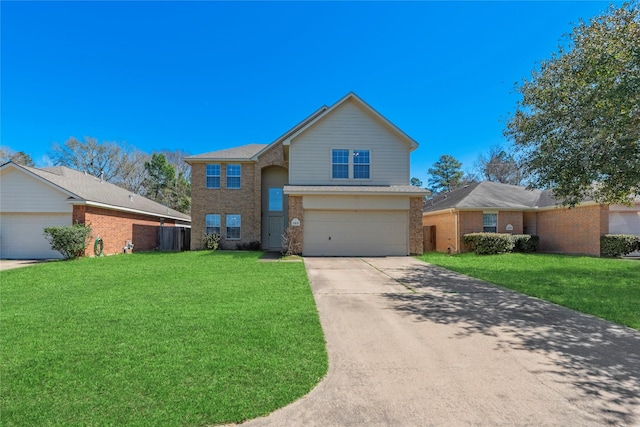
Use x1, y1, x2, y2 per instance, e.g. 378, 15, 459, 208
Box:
0, 168, 73, 213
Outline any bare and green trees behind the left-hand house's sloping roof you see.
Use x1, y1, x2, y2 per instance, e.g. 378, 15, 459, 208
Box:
0, 137, 191, 214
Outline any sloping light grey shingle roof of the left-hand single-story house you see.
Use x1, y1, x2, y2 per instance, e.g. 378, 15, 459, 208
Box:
0, 162, 191, 222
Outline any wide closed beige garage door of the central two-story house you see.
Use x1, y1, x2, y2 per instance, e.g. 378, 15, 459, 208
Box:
302, 211, 409, 256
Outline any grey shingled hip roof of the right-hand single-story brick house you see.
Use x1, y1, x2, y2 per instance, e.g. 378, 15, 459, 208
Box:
423, 181, 559, 212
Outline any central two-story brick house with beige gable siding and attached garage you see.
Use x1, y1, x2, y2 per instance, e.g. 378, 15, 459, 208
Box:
186, 93, 427, 256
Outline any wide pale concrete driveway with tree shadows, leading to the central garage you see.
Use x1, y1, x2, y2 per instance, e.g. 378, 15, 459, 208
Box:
238, 257, 640, 426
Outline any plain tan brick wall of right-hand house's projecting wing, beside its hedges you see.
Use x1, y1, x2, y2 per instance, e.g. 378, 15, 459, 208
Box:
536, 205, 609, 255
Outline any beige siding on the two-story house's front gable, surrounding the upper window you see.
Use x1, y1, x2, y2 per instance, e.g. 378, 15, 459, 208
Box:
289, 100, 410, 185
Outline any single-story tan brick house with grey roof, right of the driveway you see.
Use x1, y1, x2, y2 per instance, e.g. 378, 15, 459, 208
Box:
422, 181, 640, 255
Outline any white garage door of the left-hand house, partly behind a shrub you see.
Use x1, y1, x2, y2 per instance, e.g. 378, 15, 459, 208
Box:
0, 213, 71, 259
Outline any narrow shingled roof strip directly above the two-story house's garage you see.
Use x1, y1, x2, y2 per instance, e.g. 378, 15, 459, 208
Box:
283, 185, 429, 197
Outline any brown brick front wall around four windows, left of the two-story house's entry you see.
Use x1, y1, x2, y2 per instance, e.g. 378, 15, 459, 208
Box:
191, 144, 287, 250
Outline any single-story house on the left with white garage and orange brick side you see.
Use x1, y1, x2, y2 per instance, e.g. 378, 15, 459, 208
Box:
0, 162, 191, 259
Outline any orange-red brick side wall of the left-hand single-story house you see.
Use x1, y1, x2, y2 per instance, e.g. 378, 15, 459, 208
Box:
72, 205, 175, 256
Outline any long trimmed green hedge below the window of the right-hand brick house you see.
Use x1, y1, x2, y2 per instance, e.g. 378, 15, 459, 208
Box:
462, 233, 540, 255
